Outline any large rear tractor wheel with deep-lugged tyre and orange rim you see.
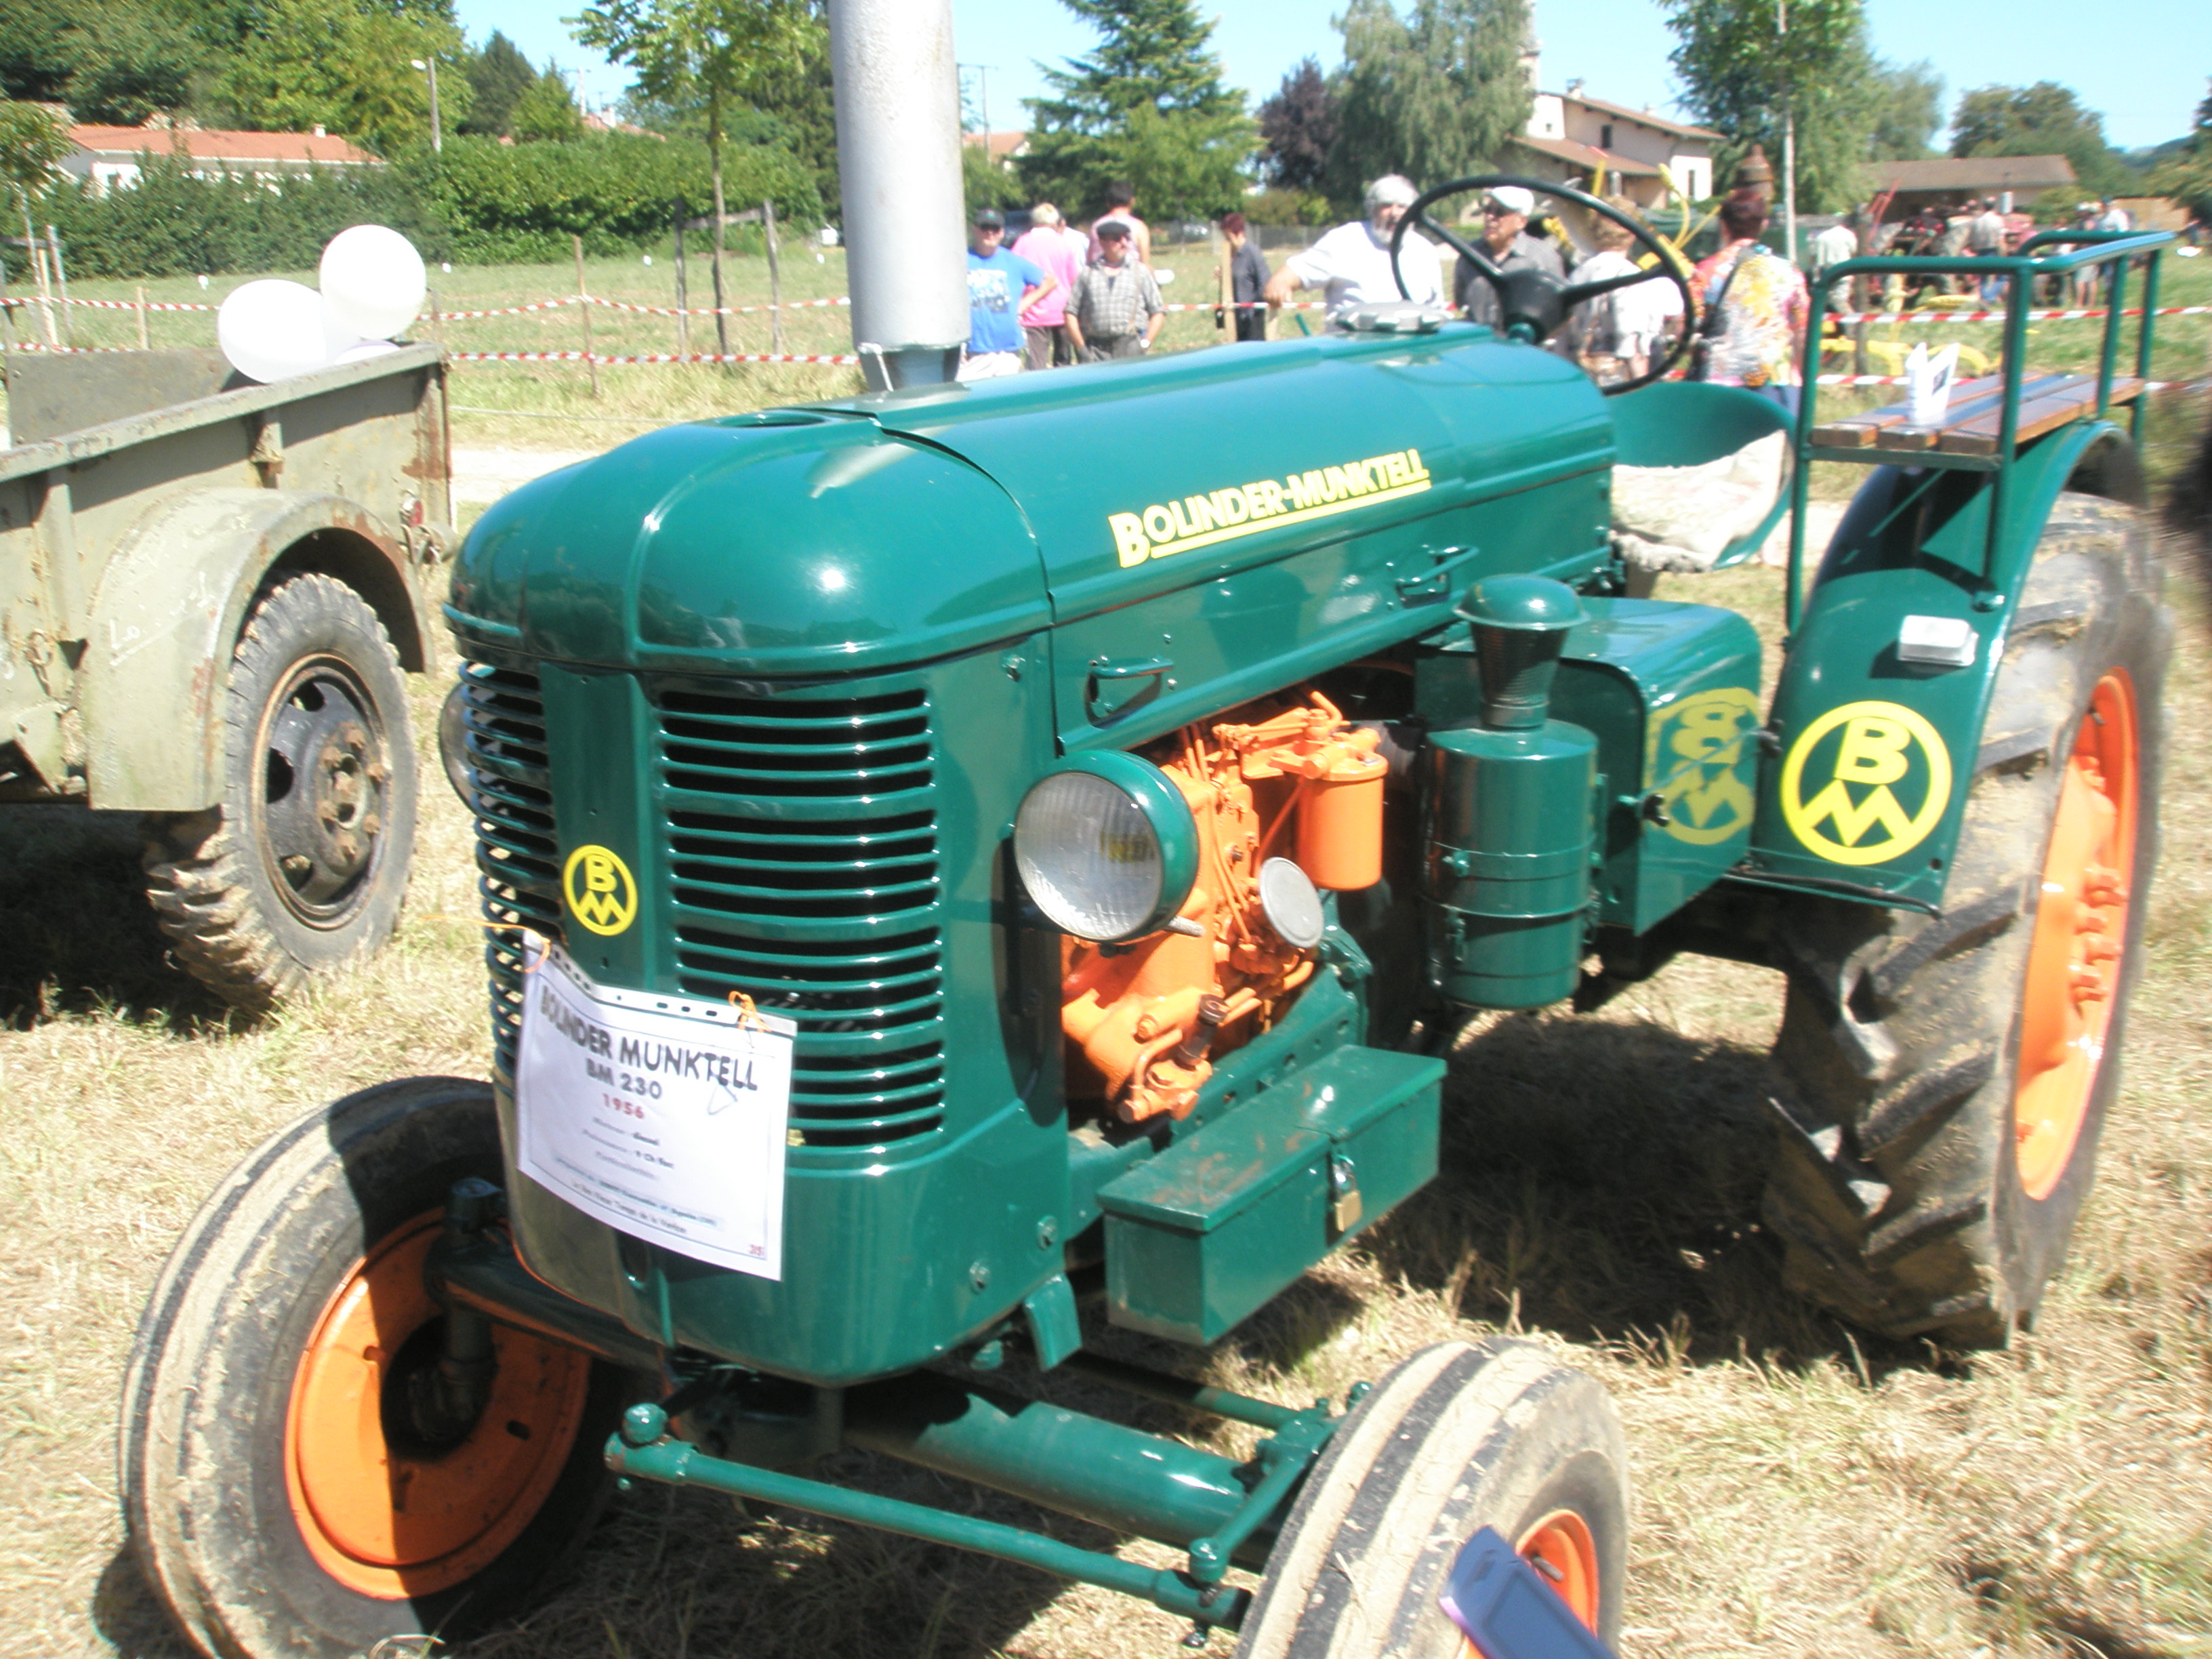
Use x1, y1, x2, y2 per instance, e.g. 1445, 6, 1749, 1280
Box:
1765, 493, 2170, 1347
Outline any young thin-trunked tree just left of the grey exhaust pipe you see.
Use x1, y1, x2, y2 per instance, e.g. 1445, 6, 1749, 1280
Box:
567, 0, 827, 354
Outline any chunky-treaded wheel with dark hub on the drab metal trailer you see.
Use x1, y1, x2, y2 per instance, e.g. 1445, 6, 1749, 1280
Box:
146, 575, 416, 1008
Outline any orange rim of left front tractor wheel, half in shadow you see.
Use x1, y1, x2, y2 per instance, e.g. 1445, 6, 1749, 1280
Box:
285, 1210, 590, 1601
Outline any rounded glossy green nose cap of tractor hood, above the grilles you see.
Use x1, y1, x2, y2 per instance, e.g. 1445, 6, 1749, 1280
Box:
449, 409, 1048, 675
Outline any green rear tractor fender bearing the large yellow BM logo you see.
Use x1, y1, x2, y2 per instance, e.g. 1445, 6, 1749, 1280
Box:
1739, 420, 2139, 909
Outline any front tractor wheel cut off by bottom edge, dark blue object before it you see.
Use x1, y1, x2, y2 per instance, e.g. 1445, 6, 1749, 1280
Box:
1237, 1340, 1628, 1659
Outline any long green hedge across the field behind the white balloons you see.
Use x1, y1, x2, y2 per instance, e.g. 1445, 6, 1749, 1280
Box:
28, 135, 823, 281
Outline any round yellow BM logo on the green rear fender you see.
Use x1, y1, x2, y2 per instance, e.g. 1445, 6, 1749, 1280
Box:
1783, 703, 1951, 865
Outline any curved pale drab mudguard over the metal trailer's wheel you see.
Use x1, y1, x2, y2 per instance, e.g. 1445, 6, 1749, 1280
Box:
77, 489, 427, 812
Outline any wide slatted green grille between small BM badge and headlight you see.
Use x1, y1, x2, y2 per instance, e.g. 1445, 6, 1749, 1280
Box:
648, 681, 945, 1148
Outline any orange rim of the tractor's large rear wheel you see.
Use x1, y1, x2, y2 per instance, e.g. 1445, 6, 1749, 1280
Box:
2013, 668, 2139, 1199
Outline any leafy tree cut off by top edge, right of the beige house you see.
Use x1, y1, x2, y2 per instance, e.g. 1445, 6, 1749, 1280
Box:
1664, 0, 1876, 212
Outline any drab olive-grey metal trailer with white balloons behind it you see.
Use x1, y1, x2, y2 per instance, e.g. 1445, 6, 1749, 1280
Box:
0, 345, 453, 1008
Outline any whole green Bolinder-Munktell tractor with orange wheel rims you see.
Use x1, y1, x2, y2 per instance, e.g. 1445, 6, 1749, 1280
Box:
124, 169, 2168, 1659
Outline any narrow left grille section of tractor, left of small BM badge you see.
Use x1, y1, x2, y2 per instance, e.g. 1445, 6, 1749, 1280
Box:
460, 661, 562, 1078
